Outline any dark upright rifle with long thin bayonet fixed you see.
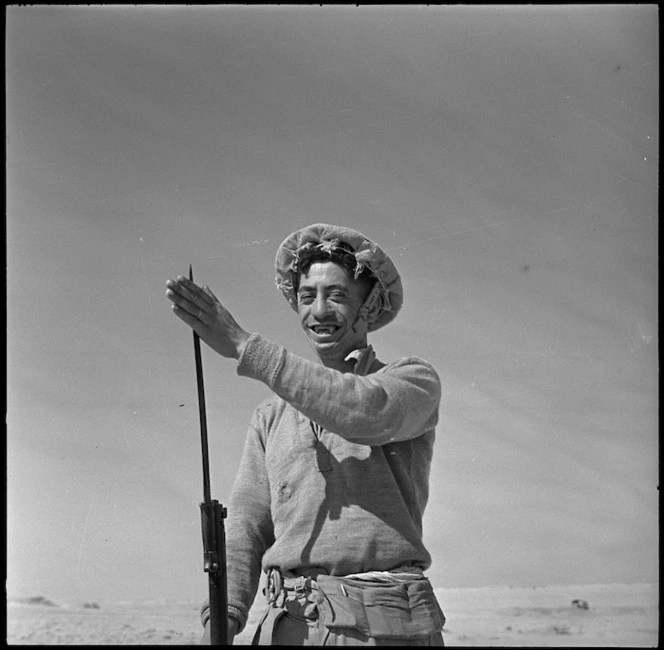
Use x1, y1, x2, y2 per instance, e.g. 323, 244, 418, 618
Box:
189, 264, 228, 645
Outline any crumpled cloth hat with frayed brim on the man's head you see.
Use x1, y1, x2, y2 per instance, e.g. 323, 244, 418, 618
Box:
274, 223, 403, 332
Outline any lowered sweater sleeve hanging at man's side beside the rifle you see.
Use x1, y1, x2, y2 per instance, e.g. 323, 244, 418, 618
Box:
226, 407, 274, 632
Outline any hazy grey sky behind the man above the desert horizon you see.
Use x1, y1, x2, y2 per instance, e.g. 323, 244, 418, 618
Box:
6, 5, 659, 601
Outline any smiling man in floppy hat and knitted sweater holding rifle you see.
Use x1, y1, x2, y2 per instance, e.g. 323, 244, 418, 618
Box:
167, 224, 445, 645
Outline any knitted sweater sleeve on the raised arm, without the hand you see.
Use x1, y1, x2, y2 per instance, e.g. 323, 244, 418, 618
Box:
237, 334, 441, 445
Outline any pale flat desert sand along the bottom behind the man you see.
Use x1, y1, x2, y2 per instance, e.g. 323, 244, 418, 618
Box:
7, 584, 659, 648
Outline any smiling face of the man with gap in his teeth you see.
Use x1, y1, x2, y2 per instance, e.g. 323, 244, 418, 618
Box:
297, 262, 371, 371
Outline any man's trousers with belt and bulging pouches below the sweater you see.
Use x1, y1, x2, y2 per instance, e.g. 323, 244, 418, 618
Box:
252, 570, 445, 647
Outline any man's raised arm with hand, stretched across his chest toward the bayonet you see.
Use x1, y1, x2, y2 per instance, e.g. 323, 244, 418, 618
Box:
166, 276, 441, 445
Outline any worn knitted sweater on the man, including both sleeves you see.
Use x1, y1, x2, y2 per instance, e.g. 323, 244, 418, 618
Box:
227, 334, 441, 630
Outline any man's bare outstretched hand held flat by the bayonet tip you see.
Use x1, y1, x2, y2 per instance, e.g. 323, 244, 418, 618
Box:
166, 275, 250, 359
